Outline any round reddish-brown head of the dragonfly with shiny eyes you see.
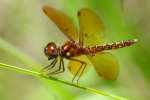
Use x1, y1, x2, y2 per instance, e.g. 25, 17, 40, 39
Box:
44, 42, 58, 60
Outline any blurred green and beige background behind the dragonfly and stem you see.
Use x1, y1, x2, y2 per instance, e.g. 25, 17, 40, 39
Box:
0, 0, 150, 100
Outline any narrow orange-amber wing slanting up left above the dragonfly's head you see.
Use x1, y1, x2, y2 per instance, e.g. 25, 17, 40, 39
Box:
42, 5, 78, 40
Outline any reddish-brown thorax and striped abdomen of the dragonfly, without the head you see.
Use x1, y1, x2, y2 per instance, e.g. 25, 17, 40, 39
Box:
59, 39, 137, 58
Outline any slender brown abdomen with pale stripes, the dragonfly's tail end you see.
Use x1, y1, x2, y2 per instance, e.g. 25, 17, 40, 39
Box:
83, 39, 137, 54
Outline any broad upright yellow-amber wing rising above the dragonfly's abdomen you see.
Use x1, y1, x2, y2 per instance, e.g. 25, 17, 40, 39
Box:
78, 8, 105, 46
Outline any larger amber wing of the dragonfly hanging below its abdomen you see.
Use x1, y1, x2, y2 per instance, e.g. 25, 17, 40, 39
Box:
88, 52, 118, 80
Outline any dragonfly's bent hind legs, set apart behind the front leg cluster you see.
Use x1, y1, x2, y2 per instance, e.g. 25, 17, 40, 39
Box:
70, 58, 87, 84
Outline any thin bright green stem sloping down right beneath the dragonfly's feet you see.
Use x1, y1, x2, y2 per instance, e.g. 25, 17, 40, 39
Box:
0, 63, 127, 100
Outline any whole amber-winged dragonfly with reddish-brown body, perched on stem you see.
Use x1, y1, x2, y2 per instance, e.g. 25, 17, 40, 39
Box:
42, 5, 137, 83
